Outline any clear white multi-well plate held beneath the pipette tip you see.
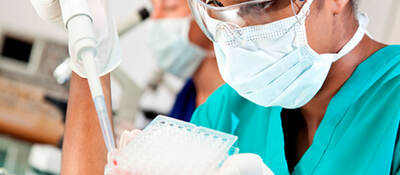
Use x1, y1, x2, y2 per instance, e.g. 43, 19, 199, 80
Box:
105, 116, 237, 175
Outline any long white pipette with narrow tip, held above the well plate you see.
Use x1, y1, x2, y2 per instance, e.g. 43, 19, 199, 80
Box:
60, 0, 115, 152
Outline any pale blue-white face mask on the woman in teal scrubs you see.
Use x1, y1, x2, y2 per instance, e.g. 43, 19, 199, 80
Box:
209, 0, 368, 109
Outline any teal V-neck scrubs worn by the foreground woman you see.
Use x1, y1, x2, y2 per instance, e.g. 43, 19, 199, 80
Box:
191, 46, 400, 175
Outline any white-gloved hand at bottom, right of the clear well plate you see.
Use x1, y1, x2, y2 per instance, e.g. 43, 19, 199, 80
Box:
217, 154, 274, 175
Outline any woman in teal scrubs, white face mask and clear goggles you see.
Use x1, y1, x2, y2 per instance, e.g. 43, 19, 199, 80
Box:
62, 0, 400, 175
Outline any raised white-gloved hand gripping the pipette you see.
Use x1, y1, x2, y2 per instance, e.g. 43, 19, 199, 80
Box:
31, 0, 122, 78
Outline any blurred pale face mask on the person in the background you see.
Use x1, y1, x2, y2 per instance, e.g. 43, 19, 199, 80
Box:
150, 17, 207, 79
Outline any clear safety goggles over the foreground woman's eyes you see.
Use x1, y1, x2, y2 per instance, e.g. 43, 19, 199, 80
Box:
189, 0, 312, 48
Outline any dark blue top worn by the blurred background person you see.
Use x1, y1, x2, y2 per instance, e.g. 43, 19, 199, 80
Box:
168, 79, 197, 122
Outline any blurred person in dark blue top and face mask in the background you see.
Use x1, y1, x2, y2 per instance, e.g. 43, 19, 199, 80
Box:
149, 0, 224, 121
